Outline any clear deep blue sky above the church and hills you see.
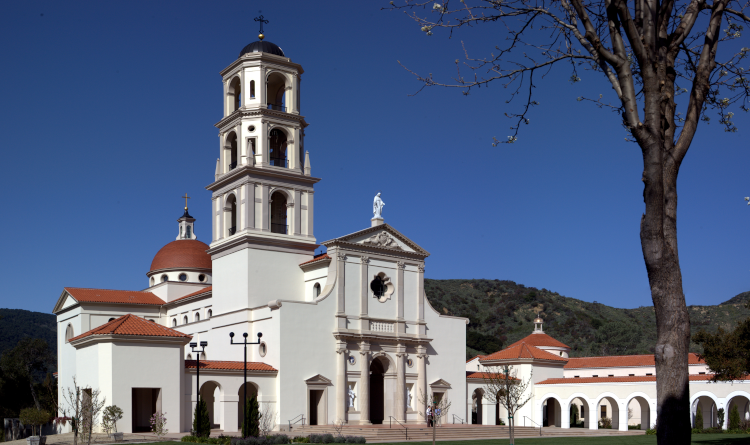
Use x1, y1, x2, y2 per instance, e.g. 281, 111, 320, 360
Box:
0, 1, 750, 312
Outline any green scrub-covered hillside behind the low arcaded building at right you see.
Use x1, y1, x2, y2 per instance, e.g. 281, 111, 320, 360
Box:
425, 279, 750, 359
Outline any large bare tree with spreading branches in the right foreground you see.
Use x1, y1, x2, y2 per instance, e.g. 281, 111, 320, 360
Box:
388, 0, 750, 445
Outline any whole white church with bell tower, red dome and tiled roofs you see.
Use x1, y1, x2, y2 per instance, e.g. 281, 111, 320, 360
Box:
53, 34, 467, 434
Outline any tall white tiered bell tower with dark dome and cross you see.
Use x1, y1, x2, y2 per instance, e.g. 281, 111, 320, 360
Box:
206, 22, 320, 310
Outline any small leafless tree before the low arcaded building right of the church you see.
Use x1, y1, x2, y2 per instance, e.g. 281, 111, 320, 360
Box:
482, 366, 531, 443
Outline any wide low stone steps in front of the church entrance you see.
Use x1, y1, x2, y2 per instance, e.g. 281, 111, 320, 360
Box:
296, 424, 645, 443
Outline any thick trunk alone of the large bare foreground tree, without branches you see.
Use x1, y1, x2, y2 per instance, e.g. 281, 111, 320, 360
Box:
640, 137, 690, 445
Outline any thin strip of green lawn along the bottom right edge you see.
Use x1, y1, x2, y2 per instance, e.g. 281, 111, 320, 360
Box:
149, 434, 750, 445
